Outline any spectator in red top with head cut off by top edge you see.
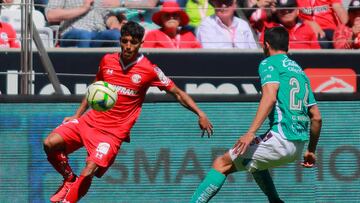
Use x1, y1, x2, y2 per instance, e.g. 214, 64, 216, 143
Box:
297, 0, 348, 49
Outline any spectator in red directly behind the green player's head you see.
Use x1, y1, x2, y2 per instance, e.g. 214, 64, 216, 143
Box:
260, 0, 320, 49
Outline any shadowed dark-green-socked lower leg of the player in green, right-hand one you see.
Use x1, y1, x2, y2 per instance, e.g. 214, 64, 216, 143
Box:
252, 169, 283, 203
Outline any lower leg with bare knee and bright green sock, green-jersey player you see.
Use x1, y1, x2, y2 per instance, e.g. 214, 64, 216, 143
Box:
191, 152, 236, 203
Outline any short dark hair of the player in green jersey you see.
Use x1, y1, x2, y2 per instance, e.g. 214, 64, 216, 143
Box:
264, 26, 289, 52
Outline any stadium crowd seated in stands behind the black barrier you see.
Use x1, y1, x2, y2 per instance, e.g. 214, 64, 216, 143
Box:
0, 0, 360, 49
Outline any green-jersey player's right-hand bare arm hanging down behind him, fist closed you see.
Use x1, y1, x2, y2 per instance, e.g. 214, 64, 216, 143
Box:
302, 105, 322, 168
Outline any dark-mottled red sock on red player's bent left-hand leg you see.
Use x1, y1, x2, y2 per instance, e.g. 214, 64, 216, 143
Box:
47, 151, 75, 180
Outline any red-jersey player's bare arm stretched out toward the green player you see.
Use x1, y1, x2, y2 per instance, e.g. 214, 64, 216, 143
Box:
169, 85, 213, 136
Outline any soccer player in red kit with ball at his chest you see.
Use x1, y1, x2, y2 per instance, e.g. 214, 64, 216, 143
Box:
44, 21, 213, 203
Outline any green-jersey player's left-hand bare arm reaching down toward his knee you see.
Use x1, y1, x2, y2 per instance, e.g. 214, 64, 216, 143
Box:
234, 83, 279, 155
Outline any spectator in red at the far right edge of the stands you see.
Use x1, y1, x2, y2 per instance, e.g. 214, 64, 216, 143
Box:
334, 0, 360, 49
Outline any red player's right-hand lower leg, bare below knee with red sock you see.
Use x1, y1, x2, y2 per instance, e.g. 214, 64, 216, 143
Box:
63, 161, 99, 203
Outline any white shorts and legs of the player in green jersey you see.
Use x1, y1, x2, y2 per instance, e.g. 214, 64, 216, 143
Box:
191, 133, 295, 202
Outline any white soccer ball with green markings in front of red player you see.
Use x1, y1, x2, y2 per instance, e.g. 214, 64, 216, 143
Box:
86, 81, 117, 111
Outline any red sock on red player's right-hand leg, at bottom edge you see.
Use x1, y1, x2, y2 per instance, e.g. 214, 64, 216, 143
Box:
63, 175, 92, 203
